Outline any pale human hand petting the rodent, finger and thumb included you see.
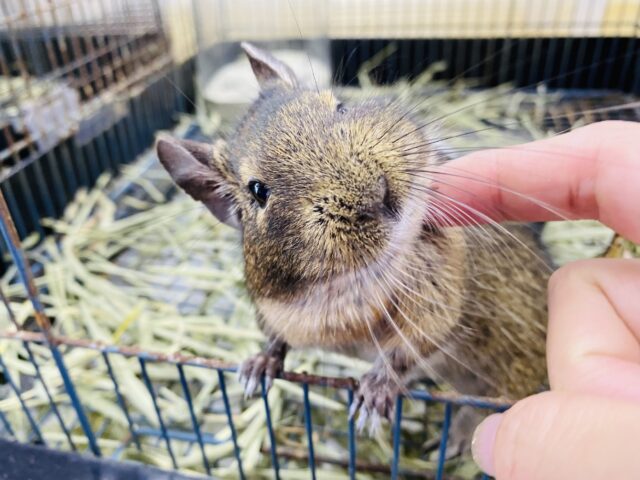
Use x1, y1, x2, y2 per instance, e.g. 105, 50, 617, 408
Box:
439, 122, 640, 480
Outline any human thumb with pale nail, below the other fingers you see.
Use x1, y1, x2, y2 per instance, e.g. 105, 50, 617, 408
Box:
472, 392, 640, 480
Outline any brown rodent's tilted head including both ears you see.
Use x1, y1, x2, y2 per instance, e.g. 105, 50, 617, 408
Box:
157, 44, 440, 299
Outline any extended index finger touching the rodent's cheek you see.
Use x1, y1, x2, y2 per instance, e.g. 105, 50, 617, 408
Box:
433, 121, 640, 242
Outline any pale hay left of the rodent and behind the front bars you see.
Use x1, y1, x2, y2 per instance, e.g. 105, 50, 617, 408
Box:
0, 159, 440, 478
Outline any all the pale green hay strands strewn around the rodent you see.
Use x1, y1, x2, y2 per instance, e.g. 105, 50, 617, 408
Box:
0, 73, 640, 479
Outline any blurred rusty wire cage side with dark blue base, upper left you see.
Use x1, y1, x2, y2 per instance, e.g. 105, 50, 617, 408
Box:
0, 0, 195, 244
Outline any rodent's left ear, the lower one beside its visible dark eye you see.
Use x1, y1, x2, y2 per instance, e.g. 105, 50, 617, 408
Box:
156, 136, 240, 228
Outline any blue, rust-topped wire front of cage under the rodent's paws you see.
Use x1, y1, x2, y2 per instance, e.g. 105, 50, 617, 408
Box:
0, 214, 509, 479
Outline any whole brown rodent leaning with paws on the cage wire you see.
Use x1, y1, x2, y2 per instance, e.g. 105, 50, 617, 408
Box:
157, 44, 549, 444
